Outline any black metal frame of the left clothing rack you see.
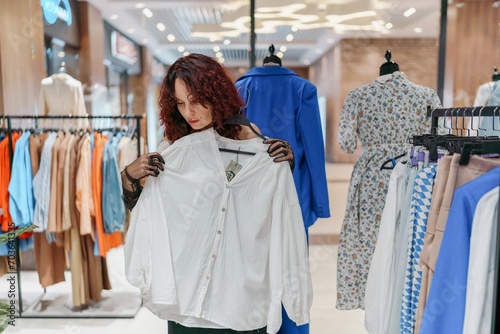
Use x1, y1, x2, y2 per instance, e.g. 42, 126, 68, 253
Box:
2, 115, 142, 319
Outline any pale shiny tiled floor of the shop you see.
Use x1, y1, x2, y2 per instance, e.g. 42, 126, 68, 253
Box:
0, 164, 366, 334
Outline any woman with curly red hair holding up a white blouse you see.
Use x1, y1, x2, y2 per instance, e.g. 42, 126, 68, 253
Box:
122, 54, 309, 334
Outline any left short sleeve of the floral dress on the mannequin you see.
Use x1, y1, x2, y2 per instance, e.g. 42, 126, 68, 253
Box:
339, 90, 358, 153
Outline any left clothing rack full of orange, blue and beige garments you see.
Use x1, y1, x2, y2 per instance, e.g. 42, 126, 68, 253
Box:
0, 115, 144, 318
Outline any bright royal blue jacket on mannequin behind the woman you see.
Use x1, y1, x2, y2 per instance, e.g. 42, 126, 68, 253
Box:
235, 66, 330, 228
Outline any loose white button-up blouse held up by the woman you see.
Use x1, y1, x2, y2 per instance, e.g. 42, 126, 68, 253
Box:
125, 129, 312, 333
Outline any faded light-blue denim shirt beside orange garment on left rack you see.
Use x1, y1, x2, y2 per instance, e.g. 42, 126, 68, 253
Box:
102, 133, 125, 233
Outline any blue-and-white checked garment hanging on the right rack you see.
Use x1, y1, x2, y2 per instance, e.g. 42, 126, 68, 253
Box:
400, 164, 437, 333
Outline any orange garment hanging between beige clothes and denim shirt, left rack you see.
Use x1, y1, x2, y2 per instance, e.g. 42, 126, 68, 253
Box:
92, 132, 123, 257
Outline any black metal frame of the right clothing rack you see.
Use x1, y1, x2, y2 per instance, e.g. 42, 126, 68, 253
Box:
427, 106, 500, 334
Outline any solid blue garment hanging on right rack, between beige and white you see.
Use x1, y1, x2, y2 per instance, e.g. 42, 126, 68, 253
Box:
420, 167, 500, 334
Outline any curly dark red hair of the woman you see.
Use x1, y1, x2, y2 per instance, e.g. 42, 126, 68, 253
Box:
159, 53, 244, 143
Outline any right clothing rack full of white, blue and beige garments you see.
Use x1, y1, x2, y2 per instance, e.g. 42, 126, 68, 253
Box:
365, 107, 500, 334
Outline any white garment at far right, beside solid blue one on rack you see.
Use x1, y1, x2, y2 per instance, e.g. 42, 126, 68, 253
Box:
463, 187, 500, 334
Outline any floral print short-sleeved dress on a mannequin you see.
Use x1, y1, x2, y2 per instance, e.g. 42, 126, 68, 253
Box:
336, 72, 441, 310
